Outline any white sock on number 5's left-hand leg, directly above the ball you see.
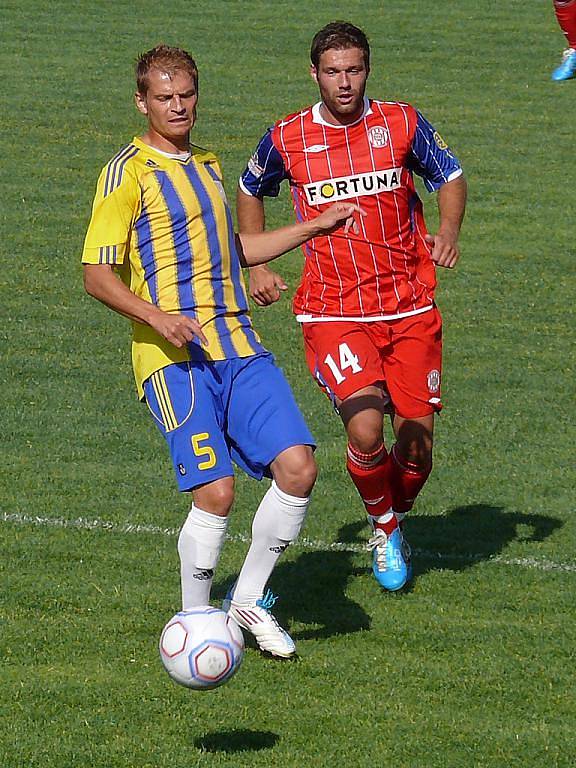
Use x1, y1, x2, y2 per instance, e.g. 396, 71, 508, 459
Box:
178, 504, 228, 611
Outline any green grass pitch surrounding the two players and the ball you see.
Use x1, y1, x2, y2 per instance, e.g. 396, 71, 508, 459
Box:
0, 0, 576, 768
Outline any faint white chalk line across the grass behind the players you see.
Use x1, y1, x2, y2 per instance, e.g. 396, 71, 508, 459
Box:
0, 512, 576, 573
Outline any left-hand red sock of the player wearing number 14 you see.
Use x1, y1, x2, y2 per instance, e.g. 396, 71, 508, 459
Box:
346, 444, 398, 533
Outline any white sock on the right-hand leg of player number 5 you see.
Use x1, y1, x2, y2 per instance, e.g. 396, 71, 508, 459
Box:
233, 481, 309, 603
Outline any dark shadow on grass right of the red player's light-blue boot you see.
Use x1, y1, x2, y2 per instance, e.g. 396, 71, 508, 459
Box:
405, 504, 563, 578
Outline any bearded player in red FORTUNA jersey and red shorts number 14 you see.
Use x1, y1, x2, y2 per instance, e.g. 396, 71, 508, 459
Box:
238, 22, 466, 590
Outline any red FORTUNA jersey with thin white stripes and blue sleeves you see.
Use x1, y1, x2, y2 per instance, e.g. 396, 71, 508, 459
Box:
240, 99, 462, 322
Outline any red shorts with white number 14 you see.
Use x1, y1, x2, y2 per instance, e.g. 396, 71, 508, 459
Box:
302, 307, 442, 419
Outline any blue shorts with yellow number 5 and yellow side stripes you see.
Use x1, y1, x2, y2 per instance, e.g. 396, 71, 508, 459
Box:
144, 354, 315, 491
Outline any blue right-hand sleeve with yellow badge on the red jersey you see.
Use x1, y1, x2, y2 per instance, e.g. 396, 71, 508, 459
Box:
408, 112, 462, 192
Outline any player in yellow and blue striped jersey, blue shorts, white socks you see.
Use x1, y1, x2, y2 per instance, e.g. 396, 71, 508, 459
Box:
82, 46, 360, 657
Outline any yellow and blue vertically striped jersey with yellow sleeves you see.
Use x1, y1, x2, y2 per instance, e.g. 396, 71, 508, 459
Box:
82, 138, 265, 397
